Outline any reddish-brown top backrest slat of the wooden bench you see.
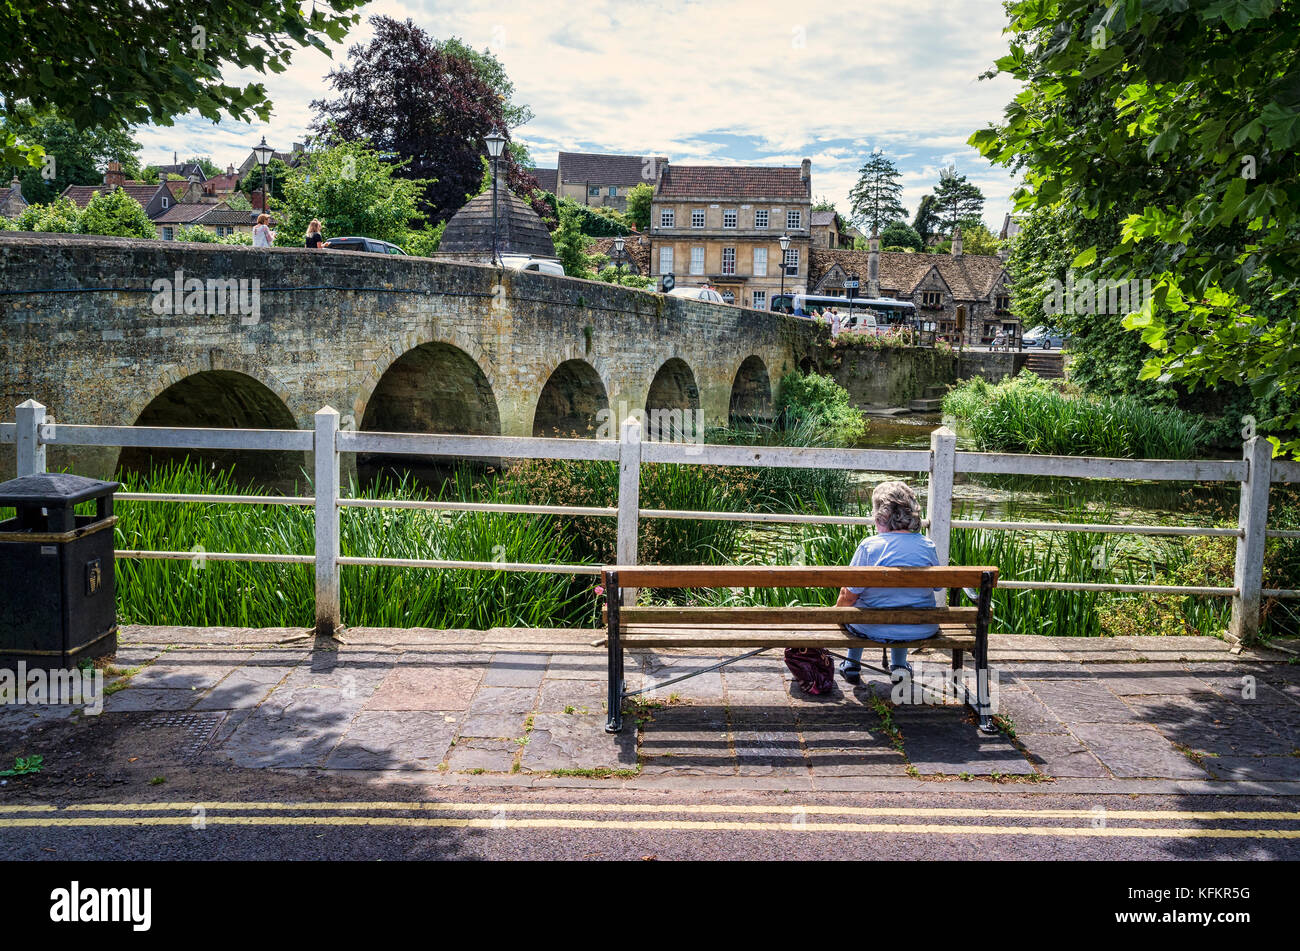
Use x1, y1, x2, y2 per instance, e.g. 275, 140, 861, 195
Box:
603, 565, 997, 587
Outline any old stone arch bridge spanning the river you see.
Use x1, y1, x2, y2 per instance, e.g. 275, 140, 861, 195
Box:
0, 234, 819, 478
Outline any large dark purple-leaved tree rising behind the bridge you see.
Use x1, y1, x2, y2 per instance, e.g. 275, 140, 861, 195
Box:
312, 17, 537, 222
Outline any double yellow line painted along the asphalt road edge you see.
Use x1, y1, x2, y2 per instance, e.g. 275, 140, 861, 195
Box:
0, 802, 1300, 839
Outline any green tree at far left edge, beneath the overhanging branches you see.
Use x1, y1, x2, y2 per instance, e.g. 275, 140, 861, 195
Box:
0, 105, 140, 204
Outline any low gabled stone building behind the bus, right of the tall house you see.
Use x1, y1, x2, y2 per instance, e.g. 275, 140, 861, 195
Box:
809, 230, 1021, 344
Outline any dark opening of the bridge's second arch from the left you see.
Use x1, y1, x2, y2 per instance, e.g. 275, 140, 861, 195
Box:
356, 340, 501, 485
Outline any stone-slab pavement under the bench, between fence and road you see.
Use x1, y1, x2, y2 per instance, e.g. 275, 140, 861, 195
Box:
0, 628, 1300, 781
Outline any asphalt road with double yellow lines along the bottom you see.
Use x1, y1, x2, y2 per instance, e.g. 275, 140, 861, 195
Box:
0, 785, 1300, 861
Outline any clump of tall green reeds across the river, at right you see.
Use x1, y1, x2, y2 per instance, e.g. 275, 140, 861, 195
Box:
944, 373, 1206, 459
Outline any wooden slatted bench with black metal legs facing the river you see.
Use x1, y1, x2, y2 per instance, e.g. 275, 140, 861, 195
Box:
602, 565, 997, 733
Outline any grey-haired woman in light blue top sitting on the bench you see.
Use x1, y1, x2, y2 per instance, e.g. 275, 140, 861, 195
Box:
836, 482, 939, 683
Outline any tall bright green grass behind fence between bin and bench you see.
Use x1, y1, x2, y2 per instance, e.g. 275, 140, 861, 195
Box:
116, 464, 594, 629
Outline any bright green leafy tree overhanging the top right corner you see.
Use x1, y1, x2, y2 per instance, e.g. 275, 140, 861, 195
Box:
971, 0, 1300, 452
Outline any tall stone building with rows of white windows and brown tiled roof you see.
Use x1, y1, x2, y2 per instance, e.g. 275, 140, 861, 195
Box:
650, 159, 813, 311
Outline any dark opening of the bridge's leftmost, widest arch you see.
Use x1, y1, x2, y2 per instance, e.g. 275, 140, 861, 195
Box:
117, 368, 306, 491
